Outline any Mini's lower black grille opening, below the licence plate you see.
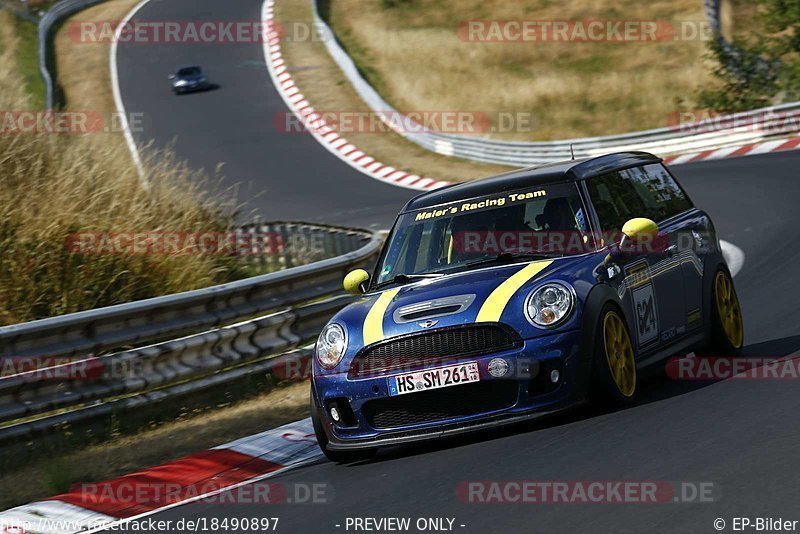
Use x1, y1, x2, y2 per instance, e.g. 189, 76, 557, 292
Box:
361, 380, 519, 428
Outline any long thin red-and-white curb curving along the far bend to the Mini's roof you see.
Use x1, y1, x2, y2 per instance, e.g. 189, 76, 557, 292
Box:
261, 0, 452, 191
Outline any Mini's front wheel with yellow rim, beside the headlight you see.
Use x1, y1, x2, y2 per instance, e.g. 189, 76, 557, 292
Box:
590, 303, 639, 406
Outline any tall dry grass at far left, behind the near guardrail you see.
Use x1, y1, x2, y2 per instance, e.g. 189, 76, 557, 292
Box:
0, 13, 250, 324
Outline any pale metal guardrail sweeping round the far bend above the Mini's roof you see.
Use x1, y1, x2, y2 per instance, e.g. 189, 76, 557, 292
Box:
310, 0, 800, 166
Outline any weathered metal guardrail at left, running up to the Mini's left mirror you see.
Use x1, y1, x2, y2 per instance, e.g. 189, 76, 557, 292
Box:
0, 223, 383, 443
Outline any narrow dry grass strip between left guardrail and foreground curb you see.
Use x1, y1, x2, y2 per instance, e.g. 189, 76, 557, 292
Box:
0, 382, 309, 509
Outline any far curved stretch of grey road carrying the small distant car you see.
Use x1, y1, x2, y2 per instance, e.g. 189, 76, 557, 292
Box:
117, 0, 415, 226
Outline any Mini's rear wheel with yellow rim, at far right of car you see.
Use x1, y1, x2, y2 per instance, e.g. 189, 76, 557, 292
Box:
708, 266, 744, 356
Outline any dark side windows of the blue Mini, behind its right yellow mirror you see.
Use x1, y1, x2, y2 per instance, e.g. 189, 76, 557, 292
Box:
587, 163, 692, 232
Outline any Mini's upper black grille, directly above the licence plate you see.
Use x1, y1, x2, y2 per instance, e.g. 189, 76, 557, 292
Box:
348, 323, 522, 378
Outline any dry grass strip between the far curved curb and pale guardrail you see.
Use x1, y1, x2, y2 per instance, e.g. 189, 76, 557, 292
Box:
276, 0, 508, 180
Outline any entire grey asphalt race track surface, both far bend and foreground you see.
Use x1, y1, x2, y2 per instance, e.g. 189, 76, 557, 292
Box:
118, 0, 800, 534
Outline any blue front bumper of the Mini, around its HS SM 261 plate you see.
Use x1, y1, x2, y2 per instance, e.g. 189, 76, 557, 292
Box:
312, 331, 583, 450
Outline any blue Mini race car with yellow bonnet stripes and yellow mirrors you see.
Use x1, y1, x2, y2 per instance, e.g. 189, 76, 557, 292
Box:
311, 152, 743, 462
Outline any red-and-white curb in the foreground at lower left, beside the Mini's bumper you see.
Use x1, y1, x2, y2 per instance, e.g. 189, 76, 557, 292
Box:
0, 419, 322, 534
